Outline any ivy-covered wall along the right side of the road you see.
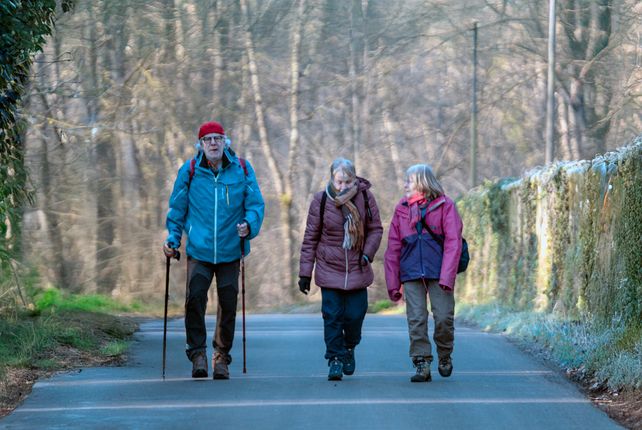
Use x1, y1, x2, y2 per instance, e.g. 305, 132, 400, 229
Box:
457, 136, 642, 325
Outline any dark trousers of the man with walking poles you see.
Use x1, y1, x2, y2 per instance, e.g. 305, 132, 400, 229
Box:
185, 257, 240, 361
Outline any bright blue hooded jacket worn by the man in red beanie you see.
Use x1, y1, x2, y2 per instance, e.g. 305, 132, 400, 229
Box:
166, 149, 265, 264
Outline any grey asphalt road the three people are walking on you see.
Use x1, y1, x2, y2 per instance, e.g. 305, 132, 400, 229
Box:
0, 314, 620, 430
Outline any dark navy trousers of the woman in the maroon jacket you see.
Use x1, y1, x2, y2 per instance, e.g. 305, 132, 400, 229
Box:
321, 288, 368, 360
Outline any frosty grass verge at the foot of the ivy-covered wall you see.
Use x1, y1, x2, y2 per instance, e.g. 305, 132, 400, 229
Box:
456, 304, 642, 390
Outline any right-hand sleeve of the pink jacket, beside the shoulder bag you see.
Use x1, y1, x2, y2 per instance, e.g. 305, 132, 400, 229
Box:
439, 199, 463, 291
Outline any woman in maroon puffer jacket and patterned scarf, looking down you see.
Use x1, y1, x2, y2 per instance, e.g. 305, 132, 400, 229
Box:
299, 158, 383, 381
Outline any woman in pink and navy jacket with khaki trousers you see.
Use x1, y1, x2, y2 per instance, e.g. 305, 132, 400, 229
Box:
385, 164, 462, 382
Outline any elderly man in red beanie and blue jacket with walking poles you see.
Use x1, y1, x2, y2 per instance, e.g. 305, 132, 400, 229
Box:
163, 121, 265, 379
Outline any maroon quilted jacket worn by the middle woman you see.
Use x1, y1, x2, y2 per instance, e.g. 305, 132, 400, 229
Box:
299, 178, 383, 290
